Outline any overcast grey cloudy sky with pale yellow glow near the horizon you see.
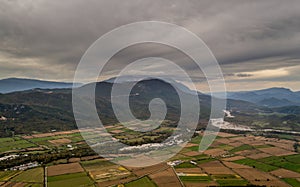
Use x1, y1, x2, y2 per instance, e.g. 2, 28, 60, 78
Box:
0, 0, 300, 91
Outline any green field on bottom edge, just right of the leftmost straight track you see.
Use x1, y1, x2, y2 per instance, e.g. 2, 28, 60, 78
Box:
47, 172, 94, 187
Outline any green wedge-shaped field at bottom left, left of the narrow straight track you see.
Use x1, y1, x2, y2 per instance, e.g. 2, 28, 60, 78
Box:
10, 167, 44, 183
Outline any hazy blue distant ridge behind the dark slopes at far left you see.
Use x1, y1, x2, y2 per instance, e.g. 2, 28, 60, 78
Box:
0, 78, 80, 93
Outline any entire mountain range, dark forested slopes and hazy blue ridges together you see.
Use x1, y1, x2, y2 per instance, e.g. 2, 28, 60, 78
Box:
0, 76, 300, 137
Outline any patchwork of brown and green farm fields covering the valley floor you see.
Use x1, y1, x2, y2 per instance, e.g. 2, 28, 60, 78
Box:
0, 129, 300, 187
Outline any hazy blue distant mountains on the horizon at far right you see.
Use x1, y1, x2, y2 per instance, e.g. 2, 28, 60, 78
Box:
227, 88, 300, 107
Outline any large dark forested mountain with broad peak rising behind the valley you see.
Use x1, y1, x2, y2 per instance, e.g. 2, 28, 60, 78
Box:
0, 79, 257, 136
